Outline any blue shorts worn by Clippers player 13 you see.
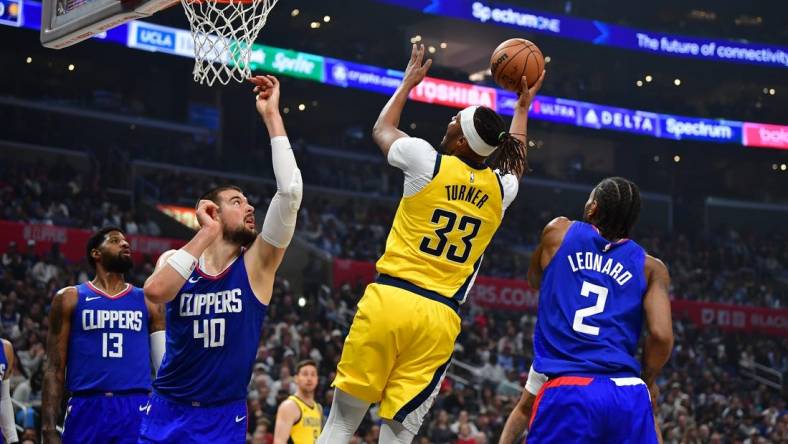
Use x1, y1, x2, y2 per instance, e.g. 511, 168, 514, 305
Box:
63, 393, 150, 444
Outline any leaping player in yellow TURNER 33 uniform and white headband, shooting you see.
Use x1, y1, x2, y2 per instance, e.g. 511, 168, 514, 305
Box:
318, 45, 544, 444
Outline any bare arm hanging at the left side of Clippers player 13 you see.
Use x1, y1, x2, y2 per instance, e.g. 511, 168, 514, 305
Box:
41, 287, 77, 444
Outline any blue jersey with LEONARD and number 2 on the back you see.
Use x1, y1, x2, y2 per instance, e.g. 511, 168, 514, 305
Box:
534, 221, 646, 377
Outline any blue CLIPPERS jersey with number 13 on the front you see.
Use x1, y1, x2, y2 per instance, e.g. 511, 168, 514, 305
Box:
66, 282, 151, 392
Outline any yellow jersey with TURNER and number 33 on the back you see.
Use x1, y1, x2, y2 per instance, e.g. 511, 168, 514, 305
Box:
377, 155, 503, 302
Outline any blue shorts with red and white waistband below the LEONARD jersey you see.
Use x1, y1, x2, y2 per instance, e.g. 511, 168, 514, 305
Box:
526, 376, 658, 444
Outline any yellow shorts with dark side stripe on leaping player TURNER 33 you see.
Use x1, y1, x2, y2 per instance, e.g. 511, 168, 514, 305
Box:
333, 278, 461, 433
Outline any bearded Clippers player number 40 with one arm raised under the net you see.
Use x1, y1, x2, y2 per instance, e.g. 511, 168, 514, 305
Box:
140, 76, 302, 443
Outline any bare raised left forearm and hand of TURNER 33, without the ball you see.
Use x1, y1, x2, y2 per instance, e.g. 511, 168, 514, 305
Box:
372, 44, 432, 157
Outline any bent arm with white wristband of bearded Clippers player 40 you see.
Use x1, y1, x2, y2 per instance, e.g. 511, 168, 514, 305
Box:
143, 200, 222, 304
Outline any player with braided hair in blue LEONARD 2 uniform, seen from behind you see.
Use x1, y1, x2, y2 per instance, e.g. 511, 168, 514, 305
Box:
500, 177, 673, 444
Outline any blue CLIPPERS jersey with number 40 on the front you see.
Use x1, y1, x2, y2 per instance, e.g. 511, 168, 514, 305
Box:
153, 253, 267, 405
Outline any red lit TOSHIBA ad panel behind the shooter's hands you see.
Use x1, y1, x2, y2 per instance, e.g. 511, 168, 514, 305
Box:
410, 77, 498, 110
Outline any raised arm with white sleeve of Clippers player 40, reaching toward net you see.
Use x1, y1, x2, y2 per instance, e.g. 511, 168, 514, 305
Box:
244, 76, 304, 304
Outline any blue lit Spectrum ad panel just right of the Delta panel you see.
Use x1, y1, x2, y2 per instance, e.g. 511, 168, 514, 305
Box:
660, 115, 742, 143
